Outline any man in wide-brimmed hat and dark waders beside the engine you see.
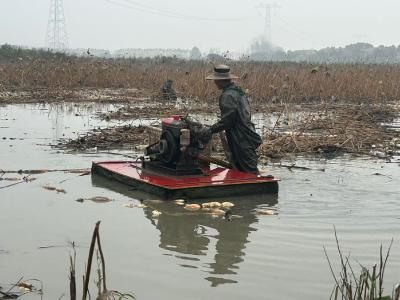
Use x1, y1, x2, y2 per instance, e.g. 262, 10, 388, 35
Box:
201, 65, 262, 174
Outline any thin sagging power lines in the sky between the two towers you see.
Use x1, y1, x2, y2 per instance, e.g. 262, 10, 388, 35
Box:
104, 0, 254, 22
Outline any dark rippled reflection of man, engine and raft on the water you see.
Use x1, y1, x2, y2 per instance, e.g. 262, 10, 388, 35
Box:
92, 175, 278, 287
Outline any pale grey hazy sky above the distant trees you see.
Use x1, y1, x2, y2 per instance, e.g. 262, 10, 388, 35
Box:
0, 0, 400, 51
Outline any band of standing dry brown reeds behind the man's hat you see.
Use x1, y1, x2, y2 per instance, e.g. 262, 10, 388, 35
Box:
0, 58, 400, 104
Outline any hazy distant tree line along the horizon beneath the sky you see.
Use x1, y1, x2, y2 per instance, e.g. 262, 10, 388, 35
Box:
0, 39, 400, 64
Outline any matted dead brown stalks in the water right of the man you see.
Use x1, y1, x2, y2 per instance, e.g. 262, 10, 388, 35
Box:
260, 105, 400, 158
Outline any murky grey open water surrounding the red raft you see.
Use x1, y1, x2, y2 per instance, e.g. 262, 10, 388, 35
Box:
0, 104, 400, 300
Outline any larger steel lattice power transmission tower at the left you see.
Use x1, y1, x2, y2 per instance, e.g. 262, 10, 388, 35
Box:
46, 0, 68, 50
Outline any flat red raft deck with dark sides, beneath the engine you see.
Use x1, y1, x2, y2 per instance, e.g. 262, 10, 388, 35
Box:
92, 161, 278, 199
